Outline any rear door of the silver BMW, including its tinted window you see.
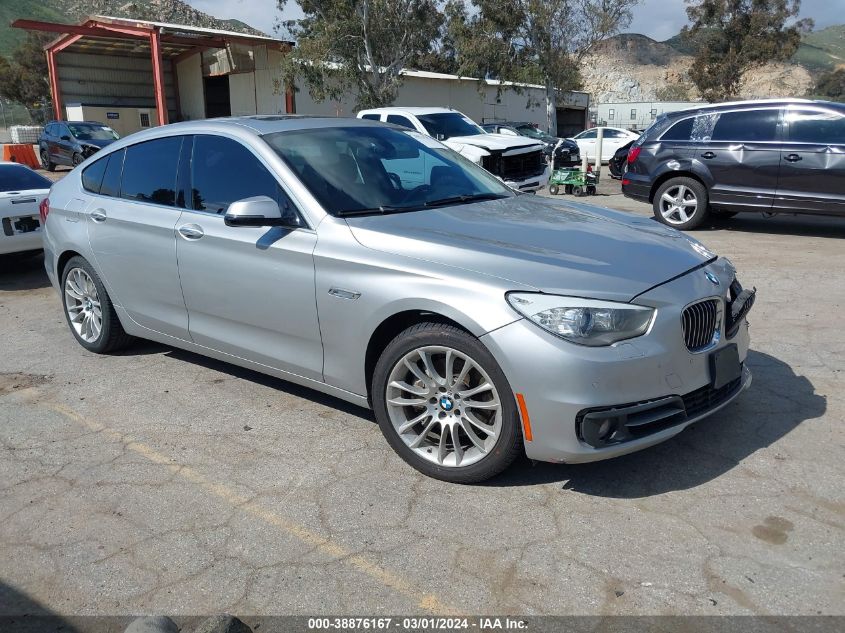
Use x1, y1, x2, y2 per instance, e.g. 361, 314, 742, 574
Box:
87, 136, 188, 340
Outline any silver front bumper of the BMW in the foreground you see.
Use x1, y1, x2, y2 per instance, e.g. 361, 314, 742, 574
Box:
482, 260, 751, 463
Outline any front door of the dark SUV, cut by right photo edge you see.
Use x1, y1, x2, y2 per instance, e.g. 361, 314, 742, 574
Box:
774, 106, 845, 215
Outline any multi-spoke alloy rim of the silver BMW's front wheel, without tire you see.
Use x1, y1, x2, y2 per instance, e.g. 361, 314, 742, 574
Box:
387, 346, 502, 468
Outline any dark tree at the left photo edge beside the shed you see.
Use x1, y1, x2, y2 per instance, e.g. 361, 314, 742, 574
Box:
0, 32, 50, 121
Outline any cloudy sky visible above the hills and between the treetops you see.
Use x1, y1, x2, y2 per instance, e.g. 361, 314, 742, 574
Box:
187, 0, 845, 41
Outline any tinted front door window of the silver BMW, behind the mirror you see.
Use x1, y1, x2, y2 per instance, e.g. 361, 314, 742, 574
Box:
191, 135, 286, 214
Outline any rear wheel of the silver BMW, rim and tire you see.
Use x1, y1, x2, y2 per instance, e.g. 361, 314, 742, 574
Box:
62, 256, 132, 354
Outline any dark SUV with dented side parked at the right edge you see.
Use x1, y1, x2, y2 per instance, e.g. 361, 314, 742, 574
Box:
622, 99, 845, 229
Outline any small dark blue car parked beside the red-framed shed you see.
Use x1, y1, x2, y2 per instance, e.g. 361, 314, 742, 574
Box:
38, 121, 120, 171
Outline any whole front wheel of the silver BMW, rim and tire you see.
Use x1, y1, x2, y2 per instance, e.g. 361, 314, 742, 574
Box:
372, 323, 522, 483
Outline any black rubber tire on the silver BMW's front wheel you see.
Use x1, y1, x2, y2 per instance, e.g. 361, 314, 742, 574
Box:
371, 323, 523, 484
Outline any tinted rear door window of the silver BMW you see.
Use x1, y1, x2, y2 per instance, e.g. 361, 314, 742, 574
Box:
120, 136, 183, 207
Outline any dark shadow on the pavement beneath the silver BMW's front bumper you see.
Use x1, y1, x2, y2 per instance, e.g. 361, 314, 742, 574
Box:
483, 351, 827, 499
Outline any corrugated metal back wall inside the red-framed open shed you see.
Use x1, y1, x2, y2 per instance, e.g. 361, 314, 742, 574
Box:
56, 52, 176, 120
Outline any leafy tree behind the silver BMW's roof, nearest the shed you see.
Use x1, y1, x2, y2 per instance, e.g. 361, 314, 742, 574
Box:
277, 0, 443, 109
